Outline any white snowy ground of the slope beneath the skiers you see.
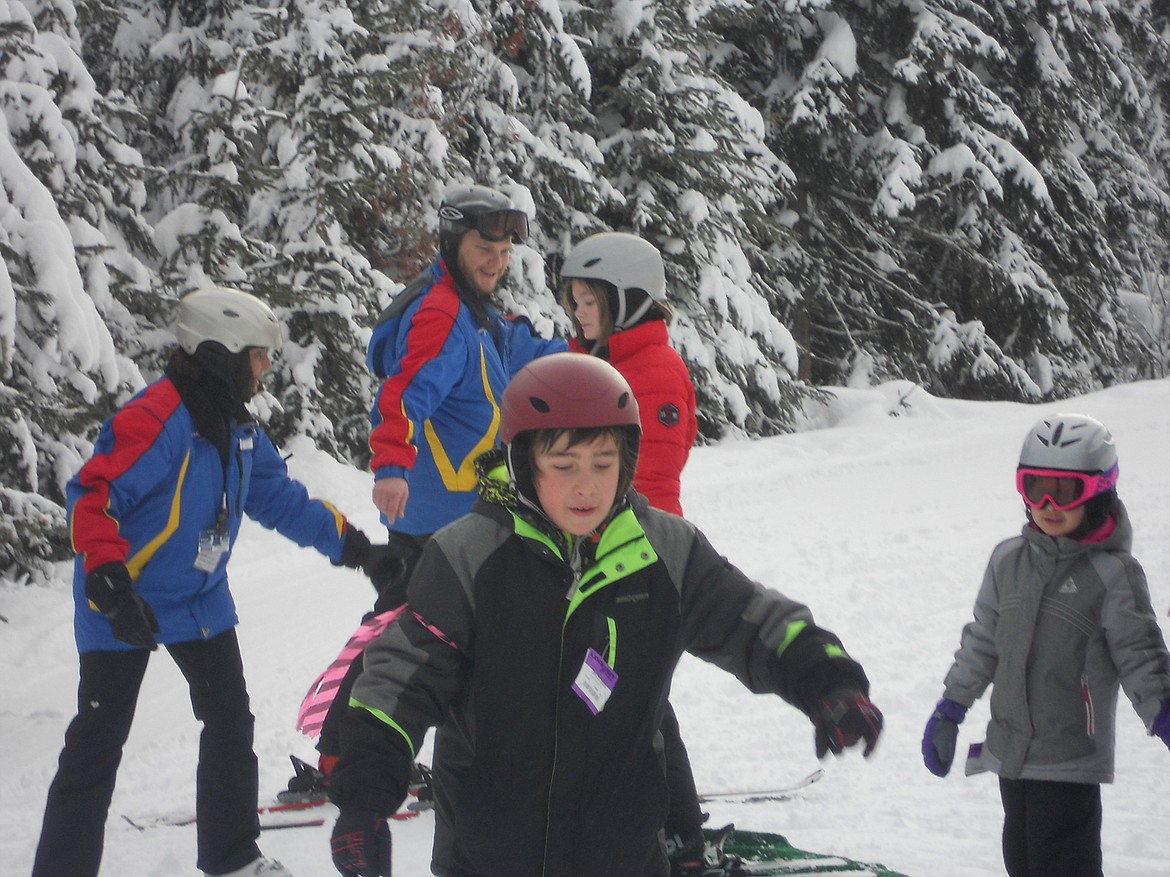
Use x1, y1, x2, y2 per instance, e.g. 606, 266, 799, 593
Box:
0, 380, 1170, 877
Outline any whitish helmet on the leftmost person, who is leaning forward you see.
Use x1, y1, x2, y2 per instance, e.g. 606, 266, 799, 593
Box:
174, 286, 283, 354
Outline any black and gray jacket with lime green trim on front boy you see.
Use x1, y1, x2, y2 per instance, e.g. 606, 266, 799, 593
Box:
331, 460, 868, 877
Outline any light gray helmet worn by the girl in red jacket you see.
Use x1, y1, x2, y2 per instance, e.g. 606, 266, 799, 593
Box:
560, 232, 666, 332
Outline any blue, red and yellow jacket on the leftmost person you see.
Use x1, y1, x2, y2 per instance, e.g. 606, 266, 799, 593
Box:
66, 378, 346, 652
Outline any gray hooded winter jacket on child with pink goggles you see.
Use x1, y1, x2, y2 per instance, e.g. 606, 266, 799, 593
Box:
945, 502, 1170, 782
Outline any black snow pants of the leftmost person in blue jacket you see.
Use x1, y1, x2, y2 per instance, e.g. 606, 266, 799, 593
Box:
33, 629, 260, 877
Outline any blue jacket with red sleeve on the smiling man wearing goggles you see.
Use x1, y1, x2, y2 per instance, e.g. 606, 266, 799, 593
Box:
367, 260, 569, 536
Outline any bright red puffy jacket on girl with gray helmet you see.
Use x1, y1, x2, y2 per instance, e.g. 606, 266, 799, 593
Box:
569, 319, 698, 515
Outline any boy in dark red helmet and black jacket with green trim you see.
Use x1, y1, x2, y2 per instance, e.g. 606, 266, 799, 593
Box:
330, 353, 882, 877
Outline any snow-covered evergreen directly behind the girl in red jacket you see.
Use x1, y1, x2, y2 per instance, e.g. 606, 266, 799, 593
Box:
573, 0, 808, 437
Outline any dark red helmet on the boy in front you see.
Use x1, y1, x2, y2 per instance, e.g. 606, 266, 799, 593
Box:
500, 353, 642, 443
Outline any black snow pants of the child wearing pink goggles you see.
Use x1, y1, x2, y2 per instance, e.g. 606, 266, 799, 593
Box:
999, 778, 1102, 877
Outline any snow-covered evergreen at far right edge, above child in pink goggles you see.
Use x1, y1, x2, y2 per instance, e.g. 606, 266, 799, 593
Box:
973, 0, 1170, 395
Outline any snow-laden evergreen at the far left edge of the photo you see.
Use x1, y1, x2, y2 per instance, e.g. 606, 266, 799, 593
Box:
0, 0, 150, 581
